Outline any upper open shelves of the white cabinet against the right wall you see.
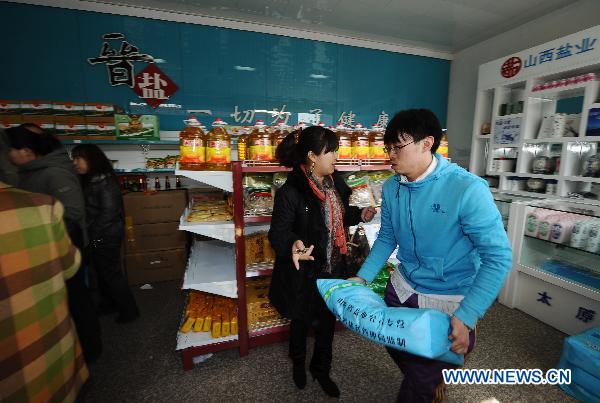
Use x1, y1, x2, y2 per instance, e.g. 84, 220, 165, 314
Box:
469, 38, 600, 204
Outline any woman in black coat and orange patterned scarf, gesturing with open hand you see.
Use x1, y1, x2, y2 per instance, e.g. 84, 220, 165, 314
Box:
269, 126, 375, 397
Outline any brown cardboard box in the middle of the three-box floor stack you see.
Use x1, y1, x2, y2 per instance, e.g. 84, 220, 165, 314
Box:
125, 222, 187, 253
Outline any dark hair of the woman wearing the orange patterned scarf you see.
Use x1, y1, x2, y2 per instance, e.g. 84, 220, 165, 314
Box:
275, 126, 339, 167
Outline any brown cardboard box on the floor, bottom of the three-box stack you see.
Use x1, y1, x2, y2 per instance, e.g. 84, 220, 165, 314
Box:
125, 249, 187, 284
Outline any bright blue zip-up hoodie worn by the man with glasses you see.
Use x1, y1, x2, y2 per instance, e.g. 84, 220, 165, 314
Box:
358, 154, 512, 329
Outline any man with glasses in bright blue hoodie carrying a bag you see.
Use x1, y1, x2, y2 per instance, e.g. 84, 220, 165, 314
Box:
353, 109, 512, 402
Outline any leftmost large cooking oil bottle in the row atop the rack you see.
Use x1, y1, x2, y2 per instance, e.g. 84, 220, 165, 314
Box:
179, 115, 206, 171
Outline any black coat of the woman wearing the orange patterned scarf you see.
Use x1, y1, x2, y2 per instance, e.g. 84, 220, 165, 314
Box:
269, 167, 361, 321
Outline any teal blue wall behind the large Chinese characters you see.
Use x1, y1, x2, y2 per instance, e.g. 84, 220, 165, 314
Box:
0, 3, 450, 130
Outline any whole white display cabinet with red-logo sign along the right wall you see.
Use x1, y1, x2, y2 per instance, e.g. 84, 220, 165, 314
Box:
469, 26, 600, 334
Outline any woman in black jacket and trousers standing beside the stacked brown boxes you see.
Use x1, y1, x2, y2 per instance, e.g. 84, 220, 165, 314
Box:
71, 144, 140, 323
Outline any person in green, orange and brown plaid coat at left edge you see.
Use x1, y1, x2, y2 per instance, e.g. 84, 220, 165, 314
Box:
0, 182, 89, 402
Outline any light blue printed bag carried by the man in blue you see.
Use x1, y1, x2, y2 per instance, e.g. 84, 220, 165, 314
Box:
317, 279, 464, 365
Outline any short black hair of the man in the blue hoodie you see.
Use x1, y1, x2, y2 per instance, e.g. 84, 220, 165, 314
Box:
383, 109, 442, 154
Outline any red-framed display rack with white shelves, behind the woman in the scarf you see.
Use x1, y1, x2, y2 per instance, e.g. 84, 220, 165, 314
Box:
175, 160, 389, 370
